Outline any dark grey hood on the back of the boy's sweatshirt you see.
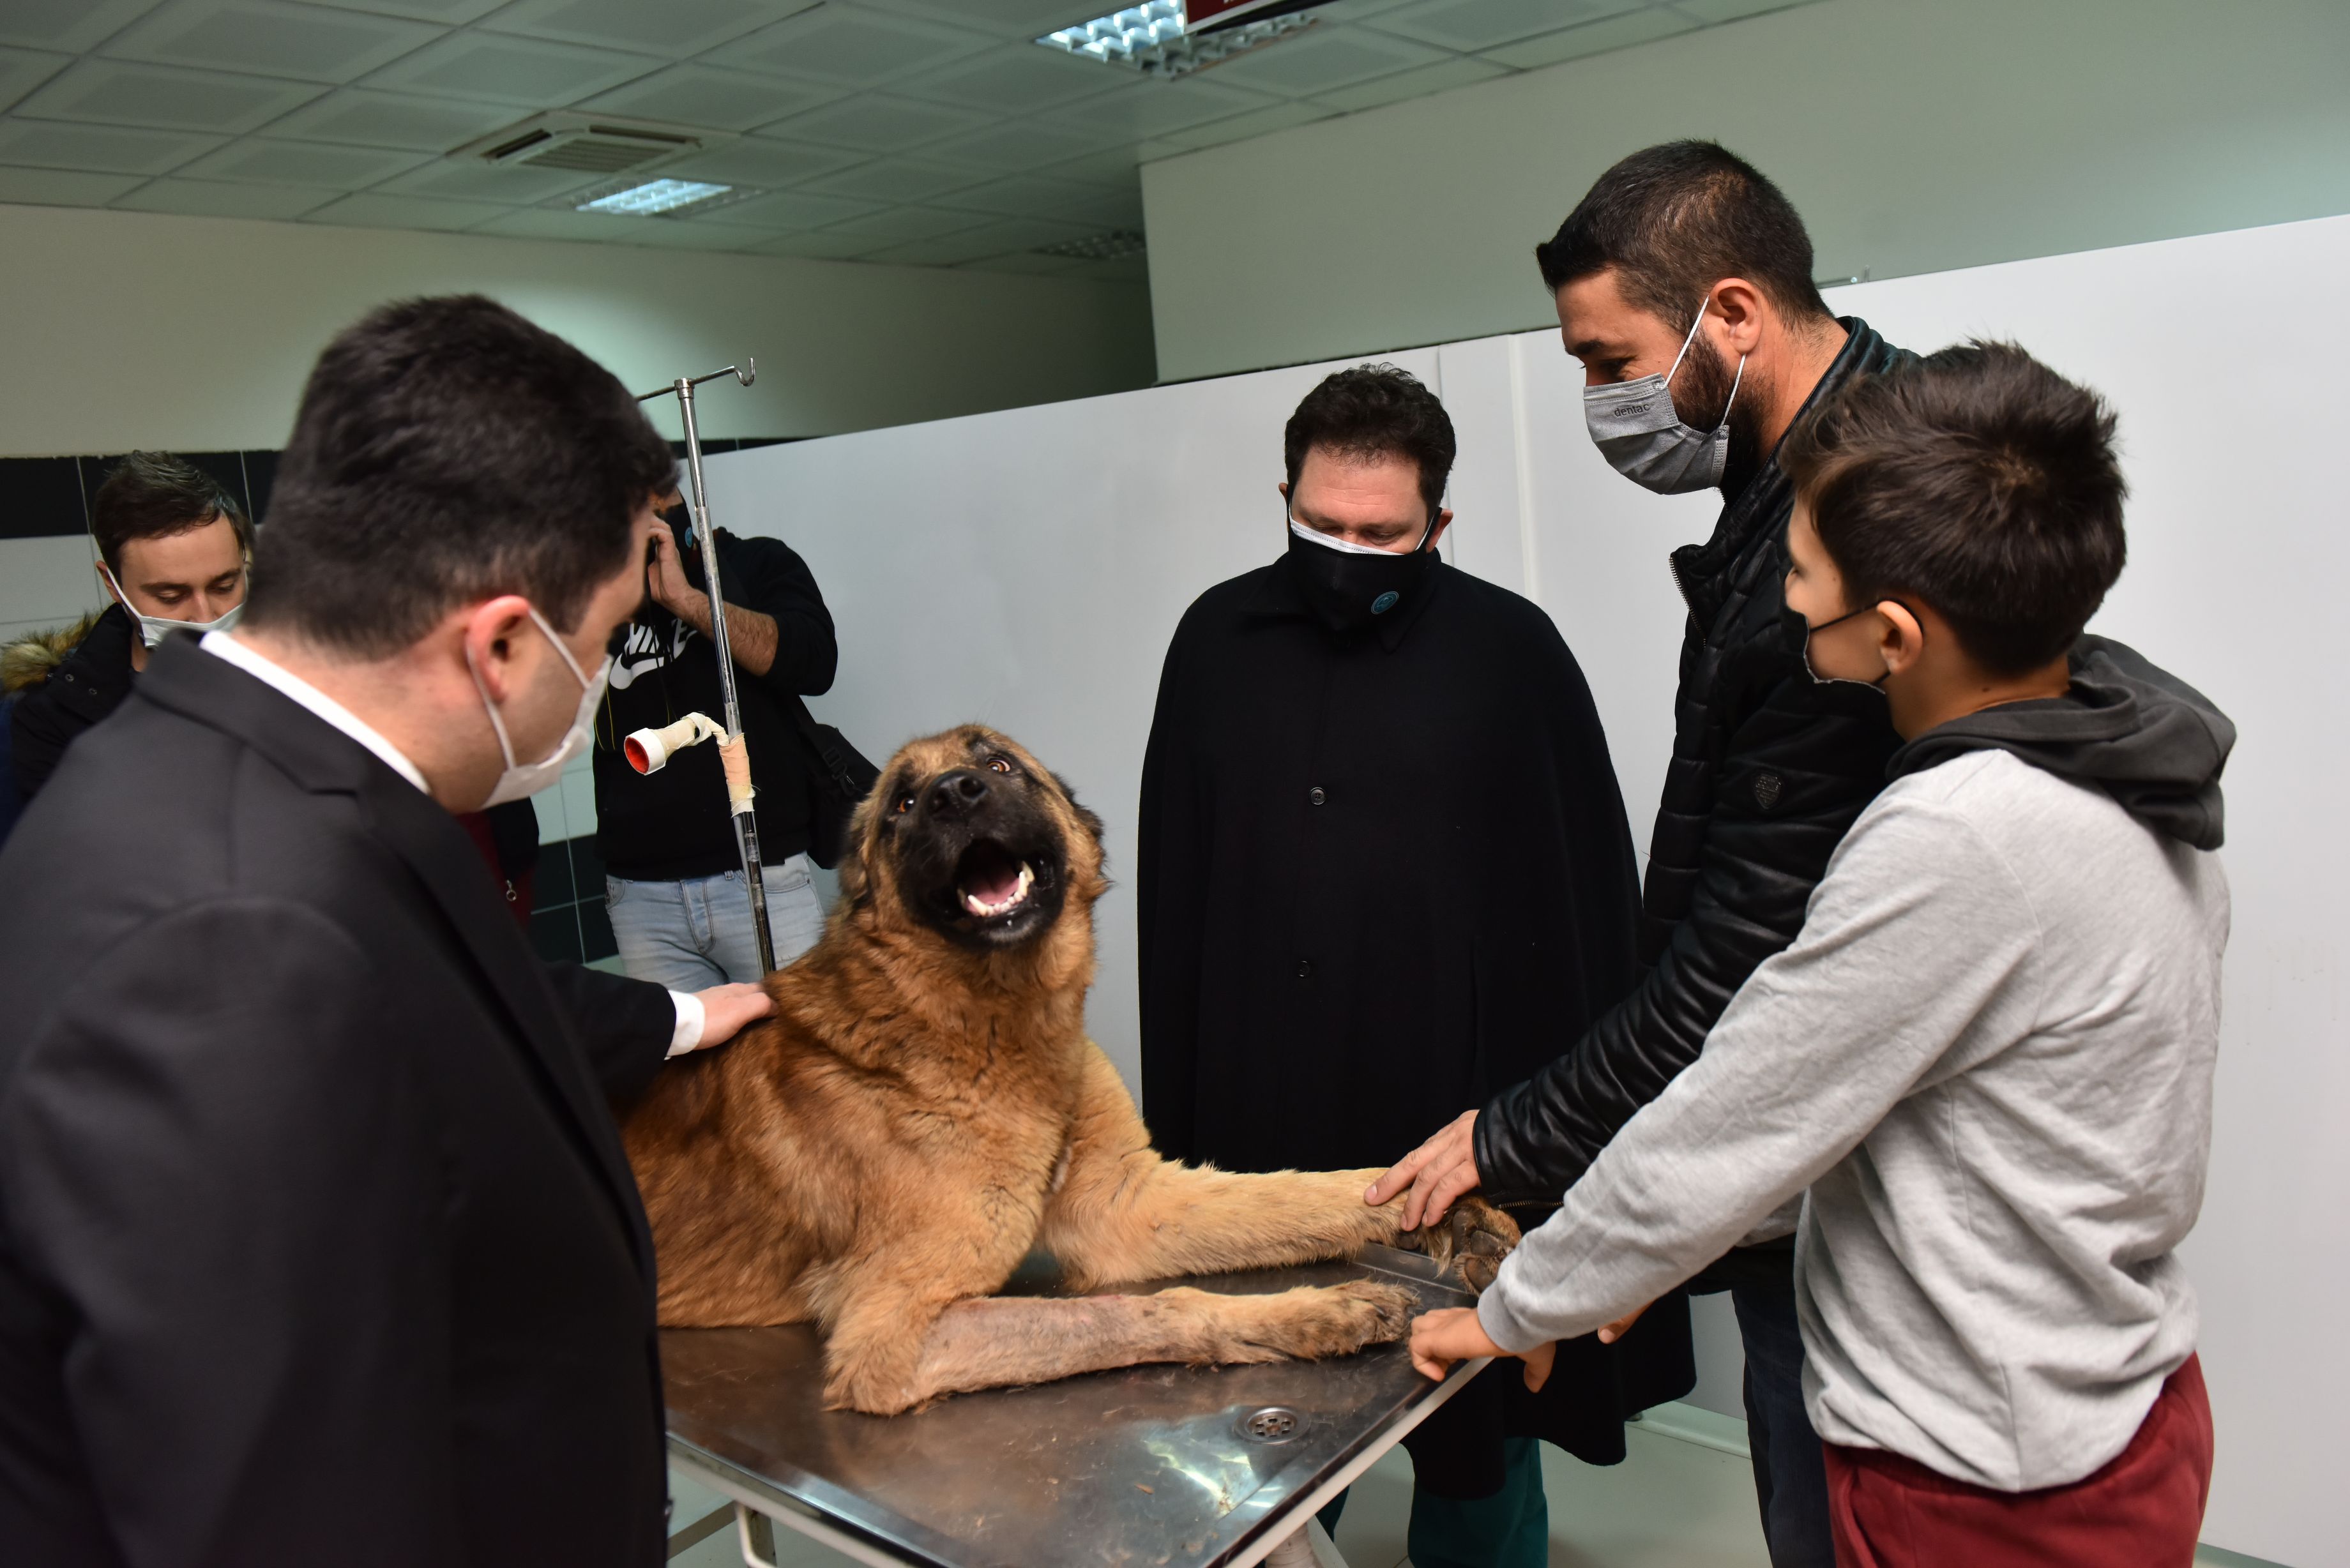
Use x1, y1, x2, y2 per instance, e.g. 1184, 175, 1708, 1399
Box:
1884, 637, 2235, 848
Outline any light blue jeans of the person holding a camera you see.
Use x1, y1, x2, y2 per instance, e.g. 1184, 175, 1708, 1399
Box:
604, 856, 825, 992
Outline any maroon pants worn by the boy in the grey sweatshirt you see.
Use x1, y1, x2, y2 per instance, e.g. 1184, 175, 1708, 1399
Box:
1824, 1357, 2211, 1568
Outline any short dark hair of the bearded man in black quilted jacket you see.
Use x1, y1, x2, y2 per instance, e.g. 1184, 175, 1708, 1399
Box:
1535, 141, 1828, 331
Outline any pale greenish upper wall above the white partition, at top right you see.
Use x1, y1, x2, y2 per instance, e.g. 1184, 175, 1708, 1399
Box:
1142, 0, 2350, 379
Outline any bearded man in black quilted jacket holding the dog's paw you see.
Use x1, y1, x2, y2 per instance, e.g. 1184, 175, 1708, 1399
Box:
1370, 141, 1906, 1568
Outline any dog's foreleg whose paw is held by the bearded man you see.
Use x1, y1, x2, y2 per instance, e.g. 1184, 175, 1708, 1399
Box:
1039, 1051, 1518, 1288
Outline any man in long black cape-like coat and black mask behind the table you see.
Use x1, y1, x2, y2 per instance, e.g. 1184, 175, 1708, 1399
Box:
1137, 366, 1694, 1568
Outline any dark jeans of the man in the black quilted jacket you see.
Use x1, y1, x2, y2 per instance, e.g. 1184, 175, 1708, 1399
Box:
1729, 1276, 1835, 1568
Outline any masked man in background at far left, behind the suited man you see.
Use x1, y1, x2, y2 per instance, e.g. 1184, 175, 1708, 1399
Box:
7, 451, 254, 799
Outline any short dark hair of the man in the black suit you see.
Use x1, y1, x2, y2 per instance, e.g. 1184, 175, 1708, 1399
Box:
245, 294, 677, 658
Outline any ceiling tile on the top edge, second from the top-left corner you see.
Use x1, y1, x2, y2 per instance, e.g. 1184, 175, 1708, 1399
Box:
106, 0, 442, 82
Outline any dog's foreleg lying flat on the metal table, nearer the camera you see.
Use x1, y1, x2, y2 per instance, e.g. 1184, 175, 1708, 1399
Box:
898, 1279, 1414, 1408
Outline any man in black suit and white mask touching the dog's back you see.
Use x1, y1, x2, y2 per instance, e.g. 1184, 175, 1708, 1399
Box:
0, 299, 766, 1568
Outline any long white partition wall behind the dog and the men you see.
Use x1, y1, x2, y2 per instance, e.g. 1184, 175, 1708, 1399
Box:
709, 218, 2350, 1568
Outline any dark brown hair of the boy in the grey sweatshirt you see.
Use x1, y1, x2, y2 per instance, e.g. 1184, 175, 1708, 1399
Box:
1779, 341, 2129, 675
